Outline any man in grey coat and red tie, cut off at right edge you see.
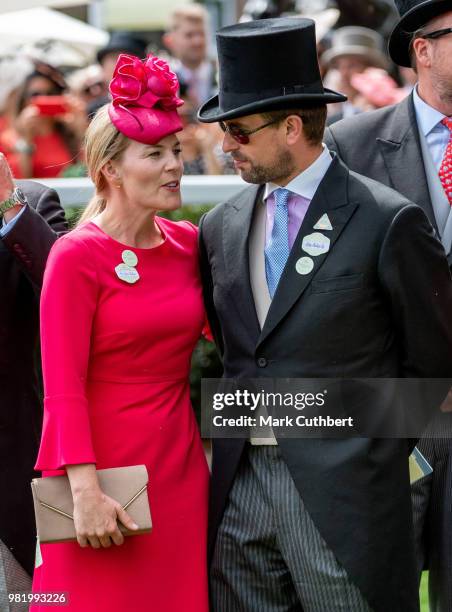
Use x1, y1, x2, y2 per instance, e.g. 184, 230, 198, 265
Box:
325, 0, 452, 612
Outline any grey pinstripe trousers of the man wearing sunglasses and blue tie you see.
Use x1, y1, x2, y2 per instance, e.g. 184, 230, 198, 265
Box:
210, 445, 370, 612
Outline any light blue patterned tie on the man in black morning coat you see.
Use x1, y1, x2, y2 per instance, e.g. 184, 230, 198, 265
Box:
265, 188, 291, 298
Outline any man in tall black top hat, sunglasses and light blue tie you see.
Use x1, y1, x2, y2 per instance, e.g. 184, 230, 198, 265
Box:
198, 18, 452, 612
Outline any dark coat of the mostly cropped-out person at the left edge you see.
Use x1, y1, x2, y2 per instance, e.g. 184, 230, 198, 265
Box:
0, 181, 67, 575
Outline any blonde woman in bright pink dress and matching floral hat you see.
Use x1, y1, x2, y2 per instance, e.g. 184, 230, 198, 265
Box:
30, 55, 208, 612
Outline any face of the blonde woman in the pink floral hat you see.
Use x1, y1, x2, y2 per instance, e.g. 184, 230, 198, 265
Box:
116, 134, 183, 210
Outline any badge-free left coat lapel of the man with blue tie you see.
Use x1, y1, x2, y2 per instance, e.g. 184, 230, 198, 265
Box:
223, 185, 263, 338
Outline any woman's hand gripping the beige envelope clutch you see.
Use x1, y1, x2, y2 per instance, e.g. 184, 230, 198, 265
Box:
74, 488, 138, 548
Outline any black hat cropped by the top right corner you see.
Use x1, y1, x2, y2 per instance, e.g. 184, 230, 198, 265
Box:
389, 0, 452, 67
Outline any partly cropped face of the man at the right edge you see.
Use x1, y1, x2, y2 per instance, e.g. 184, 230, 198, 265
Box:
424, 11, 452, 104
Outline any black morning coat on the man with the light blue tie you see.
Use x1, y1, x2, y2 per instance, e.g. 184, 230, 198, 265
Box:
200, 158, 452, 612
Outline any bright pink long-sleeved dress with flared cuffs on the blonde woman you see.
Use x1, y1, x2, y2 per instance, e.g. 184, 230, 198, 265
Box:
30, 218, 208, 612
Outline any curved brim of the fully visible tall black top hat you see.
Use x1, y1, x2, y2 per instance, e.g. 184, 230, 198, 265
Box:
198, 89, 347, 123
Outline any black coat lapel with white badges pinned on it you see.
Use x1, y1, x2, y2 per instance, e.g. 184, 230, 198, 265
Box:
258, 158, 358, 345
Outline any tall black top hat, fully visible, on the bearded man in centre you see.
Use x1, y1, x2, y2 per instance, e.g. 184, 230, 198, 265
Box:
198, 17, 347, 123
